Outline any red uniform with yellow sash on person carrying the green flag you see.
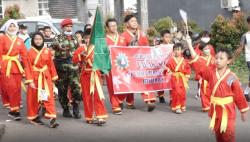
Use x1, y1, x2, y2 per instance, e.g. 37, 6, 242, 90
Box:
72, 45, 108, 126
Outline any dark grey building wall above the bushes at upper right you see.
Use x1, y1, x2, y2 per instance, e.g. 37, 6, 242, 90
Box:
148, 0, 250, 30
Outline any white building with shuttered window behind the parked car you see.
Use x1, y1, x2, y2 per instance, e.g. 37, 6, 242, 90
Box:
0, 0, 103, 23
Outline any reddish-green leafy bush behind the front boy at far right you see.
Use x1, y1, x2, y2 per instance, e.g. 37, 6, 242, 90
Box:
211, 13, 248, 83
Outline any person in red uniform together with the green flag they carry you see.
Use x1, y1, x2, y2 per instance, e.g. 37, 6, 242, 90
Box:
72, 7, 110, 126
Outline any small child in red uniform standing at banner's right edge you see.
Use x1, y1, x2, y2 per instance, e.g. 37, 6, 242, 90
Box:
166, 43, 191, 114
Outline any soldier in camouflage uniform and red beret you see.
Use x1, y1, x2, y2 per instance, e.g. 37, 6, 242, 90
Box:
53, 19, 81, 119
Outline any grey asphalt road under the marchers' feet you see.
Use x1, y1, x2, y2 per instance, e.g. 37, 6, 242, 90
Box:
0, 81, 250, 142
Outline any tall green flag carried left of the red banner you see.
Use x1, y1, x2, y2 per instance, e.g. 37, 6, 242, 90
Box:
90, 7, 111, 74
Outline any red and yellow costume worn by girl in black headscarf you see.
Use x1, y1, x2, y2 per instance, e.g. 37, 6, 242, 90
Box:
27, 47, 58, 120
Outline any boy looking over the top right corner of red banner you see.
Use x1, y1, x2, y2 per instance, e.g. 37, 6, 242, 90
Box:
157, 30, 174, 103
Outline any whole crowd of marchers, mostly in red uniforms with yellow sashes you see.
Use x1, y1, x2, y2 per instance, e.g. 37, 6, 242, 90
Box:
0, 15, 250, 142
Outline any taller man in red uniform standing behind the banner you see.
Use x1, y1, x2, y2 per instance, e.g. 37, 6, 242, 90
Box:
122, 14, 156, 112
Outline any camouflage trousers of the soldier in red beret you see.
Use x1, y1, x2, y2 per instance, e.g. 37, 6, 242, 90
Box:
56, 64, 81, 109
